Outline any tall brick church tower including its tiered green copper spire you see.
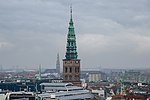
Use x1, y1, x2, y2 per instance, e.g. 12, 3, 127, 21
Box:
63, 7, 81, 86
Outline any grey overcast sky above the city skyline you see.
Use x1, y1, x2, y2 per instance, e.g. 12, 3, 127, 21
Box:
0, 0, 150, 69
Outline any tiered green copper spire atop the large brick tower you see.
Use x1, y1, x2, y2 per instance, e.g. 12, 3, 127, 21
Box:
65, 6, 78, 60
